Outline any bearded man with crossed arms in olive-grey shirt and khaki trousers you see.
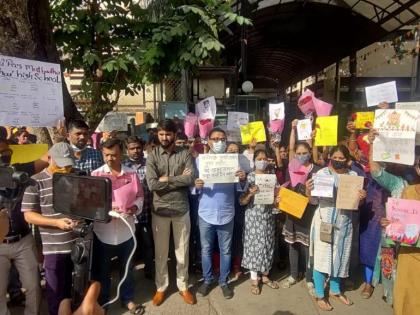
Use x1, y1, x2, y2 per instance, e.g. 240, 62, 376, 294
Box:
146, 119, 196, 306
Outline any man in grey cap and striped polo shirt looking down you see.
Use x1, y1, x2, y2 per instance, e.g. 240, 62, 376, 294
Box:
22, 142, 76, 315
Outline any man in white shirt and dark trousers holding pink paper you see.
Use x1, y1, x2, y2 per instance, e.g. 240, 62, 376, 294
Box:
92, 139, 144, 314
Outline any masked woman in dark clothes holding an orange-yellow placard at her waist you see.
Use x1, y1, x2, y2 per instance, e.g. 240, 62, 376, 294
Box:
282, 142, 320, 295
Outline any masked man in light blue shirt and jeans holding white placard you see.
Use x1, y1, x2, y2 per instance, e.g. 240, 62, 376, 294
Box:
193, 129, 246, 299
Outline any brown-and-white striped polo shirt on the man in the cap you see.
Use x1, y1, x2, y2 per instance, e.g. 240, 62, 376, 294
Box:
22, 169, 76, 255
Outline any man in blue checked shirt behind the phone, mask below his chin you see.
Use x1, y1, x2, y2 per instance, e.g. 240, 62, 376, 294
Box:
67, 119, 104, 174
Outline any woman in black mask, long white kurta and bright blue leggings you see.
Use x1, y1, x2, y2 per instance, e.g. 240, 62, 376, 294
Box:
306, 145, 366, 311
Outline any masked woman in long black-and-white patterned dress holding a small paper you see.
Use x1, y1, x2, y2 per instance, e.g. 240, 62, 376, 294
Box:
239, 150, 279, 295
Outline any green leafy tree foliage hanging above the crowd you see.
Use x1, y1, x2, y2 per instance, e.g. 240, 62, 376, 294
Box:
51, 0, 250, 124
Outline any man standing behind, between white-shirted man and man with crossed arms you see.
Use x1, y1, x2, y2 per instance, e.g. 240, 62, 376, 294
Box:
123, 136, 154, 279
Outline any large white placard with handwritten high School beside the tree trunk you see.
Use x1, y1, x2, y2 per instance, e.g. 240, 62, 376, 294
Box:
0, 55, 64, 127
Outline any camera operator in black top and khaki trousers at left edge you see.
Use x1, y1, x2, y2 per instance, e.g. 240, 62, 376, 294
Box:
0, 138, 48, 315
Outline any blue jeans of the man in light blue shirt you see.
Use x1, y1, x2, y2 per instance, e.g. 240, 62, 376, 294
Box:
198, 217, 233, 286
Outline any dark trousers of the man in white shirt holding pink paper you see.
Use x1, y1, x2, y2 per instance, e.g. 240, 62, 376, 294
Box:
92, 235, 134, 305
